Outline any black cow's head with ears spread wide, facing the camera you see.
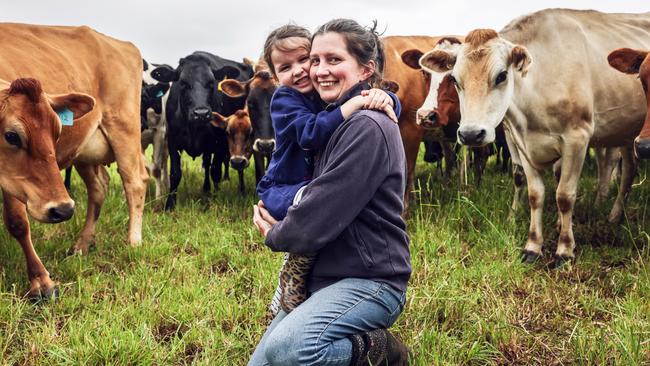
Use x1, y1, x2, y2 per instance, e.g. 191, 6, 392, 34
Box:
151, 53, 240, 128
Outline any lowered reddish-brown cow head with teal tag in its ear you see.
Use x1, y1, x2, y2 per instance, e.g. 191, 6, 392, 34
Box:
0, 79, 95, 223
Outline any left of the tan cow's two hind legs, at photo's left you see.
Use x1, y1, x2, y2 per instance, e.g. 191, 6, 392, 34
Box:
68, 164, 109, 254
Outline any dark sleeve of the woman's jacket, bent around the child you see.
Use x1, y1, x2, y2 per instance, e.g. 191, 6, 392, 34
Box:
265, 115, 389, 254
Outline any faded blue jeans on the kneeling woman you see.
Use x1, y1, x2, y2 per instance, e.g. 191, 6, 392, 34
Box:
248, 278, 406, 366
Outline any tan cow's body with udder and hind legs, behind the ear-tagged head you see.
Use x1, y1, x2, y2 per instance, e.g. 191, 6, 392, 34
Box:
0, 23, 147, 253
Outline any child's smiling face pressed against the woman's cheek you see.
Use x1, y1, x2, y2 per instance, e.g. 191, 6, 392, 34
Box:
271, 39, 314, 94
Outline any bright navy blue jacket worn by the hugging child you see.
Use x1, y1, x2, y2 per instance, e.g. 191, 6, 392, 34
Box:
257, 83, 401, 219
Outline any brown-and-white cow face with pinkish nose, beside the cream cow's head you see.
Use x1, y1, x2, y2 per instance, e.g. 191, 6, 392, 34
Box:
402, 37, 461, 138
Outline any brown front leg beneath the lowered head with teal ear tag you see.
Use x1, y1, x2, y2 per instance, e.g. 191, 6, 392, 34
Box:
2, 190, 59, 299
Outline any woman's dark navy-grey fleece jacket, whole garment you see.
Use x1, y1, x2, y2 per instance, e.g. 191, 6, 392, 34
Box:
265, 81, 411, 292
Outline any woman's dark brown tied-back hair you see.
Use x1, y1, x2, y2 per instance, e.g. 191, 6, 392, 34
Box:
311, 19, 386, 86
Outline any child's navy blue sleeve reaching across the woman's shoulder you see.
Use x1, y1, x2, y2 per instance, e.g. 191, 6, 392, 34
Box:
271, 88, 344, 150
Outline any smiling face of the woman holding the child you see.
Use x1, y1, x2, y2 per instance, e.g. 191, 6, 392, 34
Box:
309, 32, 374, 103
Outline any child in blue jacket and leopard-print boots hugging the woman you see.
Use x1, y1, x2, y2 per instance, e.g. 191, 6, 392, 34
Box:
257, 24, 400, 319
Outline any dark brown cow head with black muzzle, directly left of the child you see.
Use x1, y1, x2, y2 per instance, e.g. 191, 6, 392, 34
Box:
220, 70, 278, 156
